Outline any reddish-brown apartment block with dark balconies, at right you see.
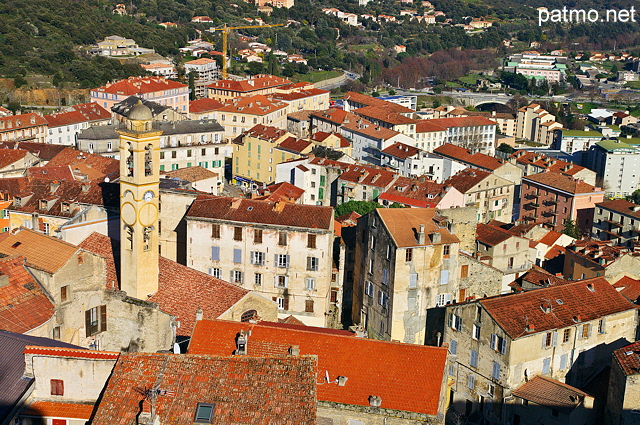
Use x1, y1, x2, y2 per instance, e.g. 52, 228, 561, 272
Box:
520, 171, 604, 232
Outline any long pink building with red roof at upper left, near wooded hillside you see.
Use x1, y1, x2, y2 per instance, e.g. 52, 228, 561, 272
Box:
91, 77, 189, 114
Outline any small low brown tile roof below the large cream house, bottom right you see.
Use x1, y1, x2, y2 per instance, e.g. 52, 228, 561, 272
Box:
513, 376, 590, 412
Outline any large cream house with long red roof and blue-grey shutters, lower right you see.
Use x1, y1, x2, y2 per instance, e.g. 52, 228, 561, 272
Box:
443, 277, 638, 422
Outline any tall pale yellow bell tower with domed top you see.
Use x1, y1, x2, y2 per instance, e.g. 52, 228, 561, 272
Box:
118, 101, 162, 300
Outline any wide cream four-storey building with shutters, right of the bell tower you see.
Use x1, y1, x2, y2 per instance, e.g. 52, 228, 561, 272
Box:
185, 195, 340, 327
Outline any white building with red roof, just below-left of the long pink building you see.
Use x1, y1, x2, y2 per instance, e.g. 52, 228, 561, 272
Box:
44, 102, 111, 146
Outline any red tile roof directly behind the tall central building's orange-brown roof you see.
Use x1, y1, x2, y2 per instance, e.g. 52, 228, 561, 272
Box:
379, 177, 451, 208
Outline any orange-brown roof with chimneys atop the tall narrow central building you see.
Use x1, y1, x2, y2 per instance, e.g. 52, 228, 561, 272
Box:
374, 208, 459, 248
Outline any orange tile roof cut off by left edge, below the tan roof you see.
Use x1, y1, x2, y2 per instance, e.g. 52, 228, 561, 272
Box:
0, 253, 55, 333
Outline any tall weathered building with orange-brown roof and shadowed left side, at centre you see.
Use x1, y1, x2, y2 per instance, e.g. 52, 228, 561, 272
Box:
352, 208, 459, 344
